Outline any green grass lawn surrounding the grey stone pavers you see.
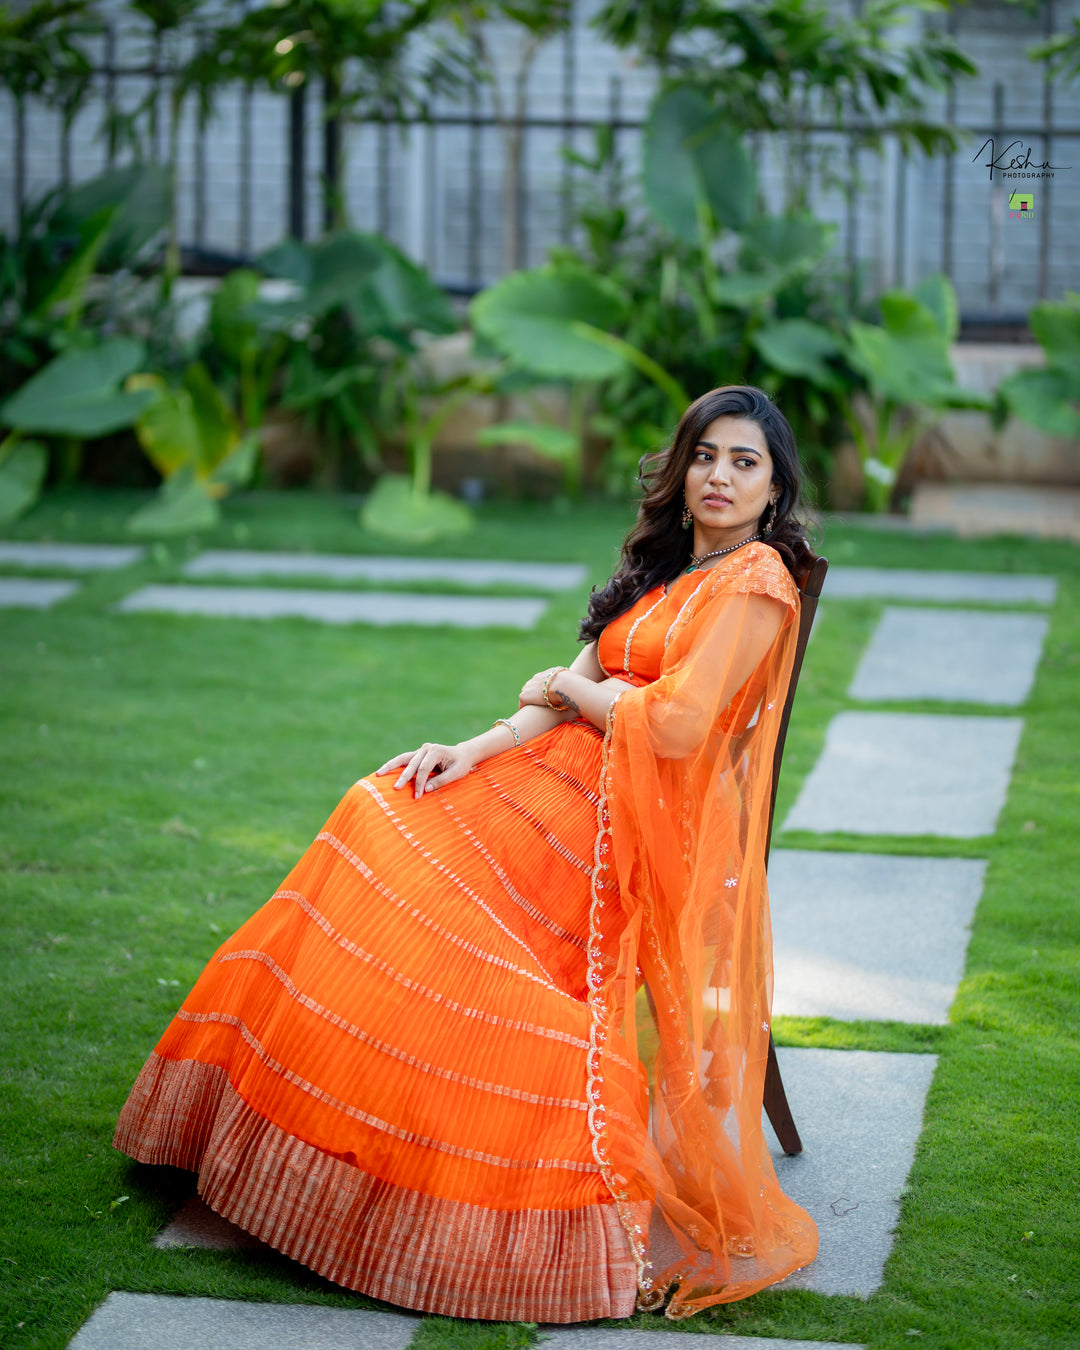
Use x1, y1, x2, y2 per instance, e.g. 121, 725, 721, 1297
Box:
0, 491, 1080, 1350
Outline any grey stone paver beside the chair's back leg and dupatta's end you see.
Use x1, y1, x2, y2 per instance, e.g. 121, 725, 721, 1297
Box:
765, 1048, 937, 1296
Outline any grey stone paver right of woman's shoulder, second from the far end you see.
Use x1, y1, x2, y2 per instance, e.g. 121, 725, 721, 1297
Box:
848, 609, 1049, 707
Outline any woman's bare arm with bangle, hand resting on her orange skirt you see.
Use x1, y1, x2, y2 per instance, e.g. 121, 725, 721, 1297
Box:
375, 643, 612, 797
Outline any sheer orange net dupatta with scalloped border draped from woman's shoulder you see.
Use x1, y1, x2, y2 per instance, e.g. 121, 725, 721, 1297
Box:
589, 545, 817, 1318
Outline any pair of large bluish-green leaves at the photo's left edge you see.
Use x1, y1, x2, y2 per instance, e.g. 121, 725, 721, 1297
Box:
0, 338, 154, 522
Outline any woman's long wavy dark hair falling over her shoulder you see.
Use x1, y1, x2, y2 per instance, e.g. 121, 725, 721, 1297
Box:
578, 385, 814, 641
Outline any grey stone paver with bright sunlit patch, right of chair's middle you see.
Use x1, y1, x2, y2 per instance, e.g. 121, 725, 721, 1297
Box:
768, 849, 987, 1025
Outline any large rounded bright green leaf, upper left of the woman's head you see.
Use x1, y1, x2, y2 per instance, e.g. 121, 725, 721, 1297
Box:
470, 265, 626, 379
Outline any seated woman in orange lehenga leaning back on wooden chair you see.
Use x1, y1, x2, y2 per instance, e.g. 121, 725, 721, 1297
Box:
116, 386, 817, 1322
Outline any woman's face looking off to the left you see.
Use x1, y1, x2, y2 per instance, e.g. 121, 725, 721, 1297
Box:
684, 417, 776, 543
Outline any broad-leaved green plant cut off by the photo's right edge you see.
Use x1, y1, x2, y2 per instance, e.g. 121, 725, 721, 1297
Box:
998, 290, 1080, 437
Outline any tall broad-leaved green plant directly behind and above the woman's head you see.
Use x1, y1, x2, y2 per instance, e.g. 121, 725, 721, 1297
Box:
534, 86, 859, 496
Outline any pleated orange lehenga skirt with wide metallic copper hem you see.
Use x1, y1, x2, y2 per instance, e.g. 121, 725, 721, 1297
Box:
115, 722, 643, 1322
